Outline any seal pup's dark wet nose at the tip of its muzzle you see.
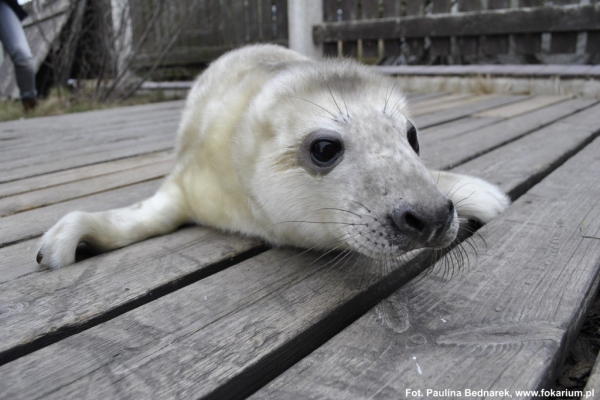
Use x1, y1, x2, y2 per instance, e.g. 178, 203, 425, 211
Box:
391, 200, 454, 246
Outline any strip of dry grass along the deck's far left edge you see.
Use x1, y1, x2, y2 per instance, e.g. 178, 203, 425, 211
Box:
0, 89, 185, 122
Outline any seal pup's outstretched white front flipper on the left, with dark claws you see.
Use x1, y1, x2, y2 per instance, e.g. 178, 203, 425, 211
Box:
36, 182, 189, 268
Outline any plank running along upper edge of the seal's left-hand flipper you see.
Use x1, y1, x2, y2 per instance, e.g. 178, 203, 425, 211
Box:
0, 179, 161, 248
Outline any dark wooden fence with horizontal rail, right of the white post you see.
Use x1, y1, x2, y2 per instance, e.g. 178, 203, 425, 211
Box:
313, 0, 600, 64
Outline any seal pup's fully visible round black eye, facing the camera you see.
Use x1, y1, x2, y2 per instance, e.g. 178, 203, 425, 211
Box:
299, 129, 344, 175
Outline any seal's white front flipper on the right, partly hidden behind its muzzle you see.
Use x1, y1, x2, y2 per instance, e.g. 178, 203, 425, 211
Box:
431, 171, 510, 223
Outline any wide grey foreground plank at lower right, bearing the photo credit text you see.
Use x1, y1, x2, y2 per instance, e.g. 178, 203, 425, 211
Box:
252, 136, 600, 399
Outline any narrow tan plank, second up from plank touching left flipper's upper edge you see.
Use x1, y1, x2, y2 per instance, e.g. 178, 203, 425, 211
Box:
0, 151, 175, 198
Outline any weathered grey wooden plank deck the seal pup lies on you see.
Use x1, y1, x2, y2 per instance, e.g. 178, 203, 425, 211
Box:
0, 94, 600, 399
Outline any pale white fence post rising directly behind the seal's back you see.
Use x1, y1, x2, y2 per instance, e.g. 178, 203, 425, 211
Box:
288, 0, 323, 59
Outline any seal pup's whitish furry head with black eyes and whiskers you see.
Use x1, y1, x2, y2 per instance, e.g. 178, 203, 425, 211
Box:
236, 61, 458, 258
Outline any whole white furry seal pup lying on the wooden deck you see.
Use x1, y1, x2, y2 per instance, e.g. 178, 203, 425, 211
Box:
37, 45, 509, 268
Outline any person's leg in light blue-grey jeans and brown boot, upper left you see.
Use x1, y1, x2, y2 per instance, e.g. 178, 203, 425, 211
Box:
0, 0, 37, 99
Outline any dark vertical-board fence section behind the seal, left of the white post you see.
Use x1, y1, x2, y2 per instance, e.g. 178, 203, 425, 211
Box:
130, 0, 288, 67
